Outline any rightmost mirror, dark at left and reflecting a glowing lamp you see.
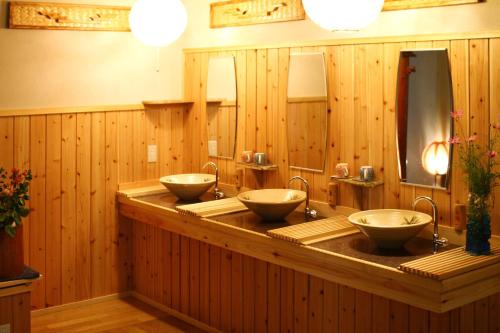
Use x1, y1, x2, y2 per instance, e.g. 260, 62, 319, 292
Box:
397, 49, 453, 188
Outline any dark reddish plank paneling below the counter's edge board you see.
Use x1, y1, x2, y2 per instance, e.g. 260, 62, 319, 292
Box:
132, 222, 500, 333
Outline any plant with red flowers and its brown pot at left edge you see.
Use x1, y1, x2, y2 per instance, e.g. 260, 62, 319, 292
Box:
0, 167, 31, 279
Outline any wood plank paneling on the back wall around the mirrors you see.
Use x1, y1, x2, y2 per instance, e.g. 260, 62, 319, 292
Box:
184, 38, 500, 234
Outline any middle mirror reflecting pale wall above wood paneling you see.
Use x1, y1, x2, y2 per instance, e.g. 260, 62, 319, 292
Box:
287, 53, 328, 171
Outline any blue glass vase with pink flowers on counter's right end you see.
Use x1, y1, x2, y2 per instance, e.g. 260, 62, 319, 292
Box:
449, 111, 500, 255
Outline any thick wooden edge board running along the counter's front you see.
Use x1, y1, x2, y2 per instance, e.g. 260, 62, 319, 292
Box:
118, 183, 500, 313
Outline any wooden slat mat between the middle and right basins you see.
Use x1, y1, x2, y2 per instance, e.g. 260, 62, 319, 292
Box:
267, 216, 359, 245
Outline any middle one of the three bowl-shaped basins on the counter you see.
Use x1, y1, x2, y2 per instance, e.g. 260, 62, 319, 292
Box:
238, 189, 306, 222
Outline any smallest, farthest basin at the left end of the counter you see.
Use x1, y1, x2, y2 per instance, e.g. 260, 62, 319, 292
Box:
160, 173, 215, 201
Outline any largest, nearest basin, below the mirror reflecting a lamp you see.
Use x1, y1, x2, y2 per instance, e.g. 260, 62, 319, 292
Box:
348, 209, 432, 249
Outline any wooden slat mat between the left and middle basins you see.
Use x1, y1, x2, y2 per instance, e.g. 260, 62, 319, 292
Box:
175, 198, 248, 217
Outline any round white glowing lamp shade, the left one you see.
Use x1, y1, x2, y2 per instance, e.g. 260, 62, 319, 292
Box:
129, 0, 187, 47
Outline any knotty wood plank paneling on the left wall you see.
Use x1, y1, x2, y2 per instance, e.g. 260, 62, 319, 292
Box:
0, 106, 189, 308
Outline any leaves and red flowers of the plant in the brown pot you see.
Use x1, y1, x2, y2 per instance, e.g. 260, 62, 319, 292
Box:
0, 167, 32, 237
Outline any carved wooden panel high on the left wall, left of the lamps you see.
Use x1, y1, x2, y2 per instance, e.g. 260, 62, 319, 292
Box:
9, 2, 130, 31
